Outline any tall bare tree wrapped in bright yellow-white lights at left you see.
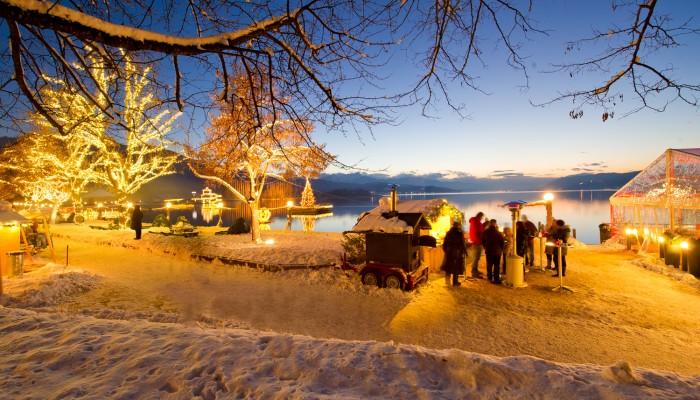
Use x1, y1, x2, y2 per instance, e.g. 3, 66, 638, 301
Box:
33, 48, 179, 208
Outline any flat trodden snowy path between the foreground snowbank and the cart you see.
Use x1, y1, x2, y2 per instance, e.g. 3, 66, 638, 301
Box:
8, 225, 700, 374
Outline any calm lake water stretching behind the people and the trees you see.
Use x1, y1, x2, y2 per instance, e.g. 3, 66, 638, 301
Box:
145, 190, 615, 244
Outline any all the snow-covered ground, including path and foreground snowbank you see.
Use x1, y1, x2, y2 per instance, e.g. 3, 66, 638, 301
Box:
0, 224, 700, 399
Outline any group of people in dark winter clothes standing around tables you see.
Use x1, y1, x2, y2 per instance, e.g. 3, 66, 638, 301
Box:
440, 211, 571, 286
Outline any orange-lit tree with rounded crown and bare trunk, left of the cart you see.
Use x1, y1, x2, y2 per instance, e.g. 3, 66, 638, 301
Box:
189, 70, 333, 241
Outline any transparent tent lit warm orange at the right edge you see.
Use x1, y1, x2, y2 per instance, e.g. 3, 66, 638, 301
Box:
610, 148, 700, 235
